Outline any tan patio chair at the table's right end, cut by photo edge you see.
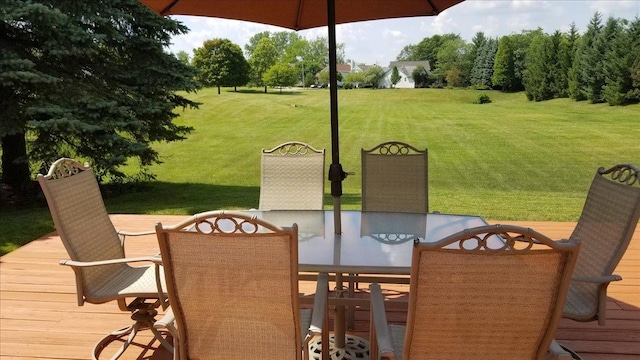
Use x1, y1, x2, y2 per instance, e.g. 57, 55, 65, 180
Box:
564, 164, 640, 325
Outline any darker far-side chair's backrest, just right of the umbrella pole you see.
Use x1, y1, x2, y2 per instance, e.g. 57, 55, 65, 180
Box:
361, 141, 429, 213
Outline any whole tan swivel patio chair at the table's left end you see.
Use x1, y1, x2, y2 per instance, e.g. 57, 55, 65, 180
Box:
38, 158, 172, 359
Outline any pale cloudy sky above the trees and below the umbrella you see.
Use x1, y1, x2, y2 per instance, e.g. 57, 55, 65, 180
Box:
168, 0, 640, 67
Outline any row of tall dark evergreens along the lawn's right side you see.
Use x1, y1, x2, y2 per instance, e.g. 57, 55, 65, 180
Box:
398, 12, 640, 105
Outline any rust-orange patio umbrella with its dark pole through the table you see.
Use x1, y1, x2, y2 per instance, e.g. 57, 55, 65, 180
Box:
140, 0, 464, 234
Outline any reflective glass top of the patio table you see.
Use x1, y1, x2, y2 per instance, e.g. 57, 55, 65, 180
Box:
250, 210, 487, 274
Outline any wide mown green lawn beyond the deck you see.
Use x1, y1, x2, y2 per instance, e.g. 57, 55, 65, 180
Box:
0, 89, 640, 253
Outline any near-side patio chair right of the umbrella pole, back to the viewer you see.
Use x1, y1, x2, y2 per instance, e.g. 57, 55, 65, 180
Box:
370, 225, 579, 360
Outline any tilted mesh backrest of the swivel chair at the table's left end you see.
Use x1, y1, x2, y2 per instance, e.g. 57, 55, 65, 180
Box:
38, 158, 127, 305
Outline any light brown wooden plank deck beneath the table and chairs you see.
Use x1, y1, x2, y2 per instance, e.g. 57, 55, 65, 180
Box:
0, 215, 640, 360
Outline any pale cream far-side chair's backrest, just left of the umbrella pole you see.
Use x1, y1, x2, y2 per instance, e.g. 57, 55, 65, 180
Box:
259, 141, 325, 210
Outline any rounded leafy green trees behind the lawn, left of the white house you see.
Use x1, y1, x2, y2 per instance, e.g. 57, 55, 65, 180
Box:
176, 31, 392, 93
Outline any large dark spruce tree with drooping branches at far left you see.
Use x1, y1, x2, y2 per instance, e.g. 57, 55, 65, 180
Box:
0, 0, 197, 188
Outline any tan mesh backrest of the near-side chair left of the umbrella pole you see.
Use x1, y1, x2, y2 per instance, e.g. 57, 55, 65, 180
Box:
156, 211, 302, 359
